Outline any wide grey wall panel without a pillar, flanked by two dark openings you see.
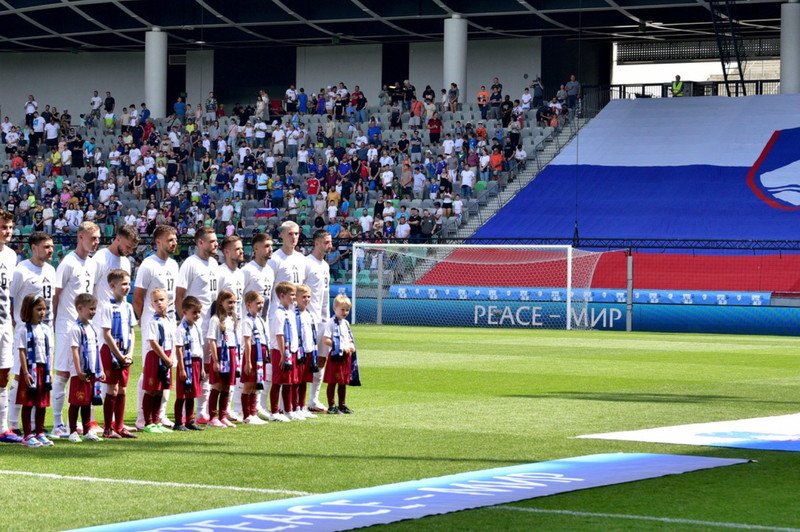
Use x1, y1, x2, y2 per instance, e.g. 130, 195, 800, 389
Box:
298, 44, 382, 105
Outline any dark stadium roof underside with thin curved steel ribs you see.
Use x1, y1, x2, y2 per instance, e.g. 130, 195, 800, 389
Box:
0, 0, 781, 52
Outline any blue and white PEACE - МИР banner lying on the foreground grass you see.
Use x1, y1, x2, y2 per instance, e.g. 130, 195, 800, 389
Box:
69, 453, 747, 532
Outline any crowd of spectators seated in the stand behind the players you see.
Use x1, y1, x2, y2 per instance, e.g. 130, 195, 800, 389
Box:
0, 76, 581, 274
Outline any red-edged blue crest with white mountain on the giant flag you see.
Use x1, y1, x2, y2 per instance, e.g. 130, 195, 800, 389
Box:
747, 128, 800, 211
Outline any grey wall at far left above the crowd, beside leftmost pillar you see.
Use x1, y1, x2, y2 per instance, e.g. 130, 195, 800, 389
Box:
0, 52, 144, 124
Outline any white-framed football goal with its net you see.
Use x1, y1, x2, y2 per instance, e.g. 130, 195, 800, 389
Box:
350, 243, 602, 329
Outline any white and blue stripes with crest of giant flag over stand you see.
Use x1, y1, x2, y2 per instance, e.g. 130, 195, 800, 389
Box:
475, 95, 800, 240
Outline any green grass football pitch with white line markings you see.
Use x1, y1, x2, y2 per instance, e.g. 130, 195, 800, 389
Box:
0, 326, 800, 532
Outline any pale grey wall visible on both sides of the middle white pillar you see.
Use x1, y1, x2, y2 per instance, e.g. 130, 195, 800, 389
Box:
409, 37, 542, 103
